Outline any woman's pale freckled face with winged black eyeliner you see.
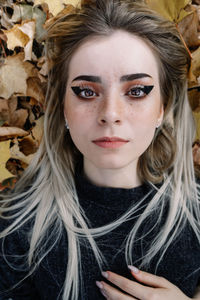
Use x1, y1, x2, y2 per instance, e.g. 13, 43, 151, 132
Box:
64, 30, 163, 177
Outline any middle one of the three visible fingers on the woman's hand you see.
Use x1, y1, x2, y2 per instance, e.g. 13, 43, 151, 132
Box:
102, 271, 153, 299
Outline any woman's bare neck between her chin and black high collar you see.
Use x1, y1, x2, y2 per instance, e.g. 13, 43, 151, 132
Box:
83, 161, 142, 189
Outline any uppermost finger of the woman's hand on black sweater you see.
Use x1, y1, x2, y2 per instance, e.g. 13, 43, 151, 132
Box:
128, 266, 173, 288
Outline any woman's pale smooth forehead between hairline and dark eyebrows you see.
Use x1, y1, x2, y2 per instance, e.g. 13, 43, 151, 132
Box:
69, 30, 158, 81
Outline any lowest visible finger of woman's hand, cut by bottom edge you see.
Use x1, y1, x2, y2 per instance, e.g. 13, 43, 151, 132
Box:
96, 281, 136, 300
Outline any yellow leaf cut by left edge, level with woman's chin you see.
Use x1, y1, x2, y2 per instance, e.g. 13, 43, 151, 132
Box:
0, 141, 13, 182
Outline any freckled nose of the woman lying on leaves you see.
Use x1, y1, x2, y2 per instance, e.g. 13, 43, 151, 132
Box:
98, 95, 123, 125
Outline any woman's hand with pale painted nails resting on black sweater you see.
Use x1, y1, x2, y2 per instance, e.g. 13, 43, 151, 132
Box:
96, 266, 191, 300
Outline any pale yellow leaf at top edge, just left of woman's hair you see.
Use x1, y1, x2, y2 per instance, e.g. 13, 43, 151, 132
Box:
34, 0, 81, 16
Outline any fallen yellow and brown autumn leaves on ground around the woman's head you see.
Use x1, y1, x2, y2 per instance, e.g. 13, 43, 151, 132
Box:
0, 0, 200, 190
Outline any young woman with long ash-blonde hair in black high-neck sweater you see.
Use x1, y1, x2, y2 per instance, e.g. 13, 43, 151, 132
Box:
0, 0, 200, 300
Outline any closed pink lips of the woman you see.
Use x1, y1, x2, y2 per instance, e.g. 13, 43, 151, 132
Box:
92, 137, 129, 149
